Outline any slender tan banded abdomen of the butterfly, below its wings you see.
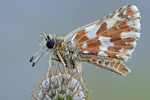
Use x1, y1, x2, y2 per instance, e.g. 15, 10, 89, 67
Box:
81, 54, 131, 76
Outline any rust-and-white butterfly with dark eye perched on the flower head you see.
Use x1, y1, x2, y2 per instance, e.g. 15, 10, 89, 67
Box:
30, 5, 141, 76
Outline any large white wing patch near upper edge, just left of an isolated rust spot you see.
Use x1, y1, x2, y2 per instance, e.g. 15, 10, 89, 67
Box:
85, 24, 100, 39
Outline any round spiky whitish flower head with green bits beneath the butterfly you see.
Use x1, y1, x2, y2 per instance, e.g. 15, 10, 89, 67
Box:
31, 63, 89, 100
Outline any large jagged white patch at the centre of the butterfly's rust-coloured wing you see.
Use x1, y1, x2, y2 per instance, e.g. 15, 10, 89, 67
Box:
98, 36, 115, 51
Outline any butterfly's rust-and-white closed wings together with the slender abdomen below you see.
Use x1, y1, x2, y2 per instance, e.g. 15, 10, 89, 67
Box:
65, 5, 140, 75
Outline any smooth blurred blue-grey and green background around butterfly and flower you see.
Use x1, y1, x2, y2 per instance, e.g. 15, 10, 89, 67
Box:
0, 0, 150, 100
